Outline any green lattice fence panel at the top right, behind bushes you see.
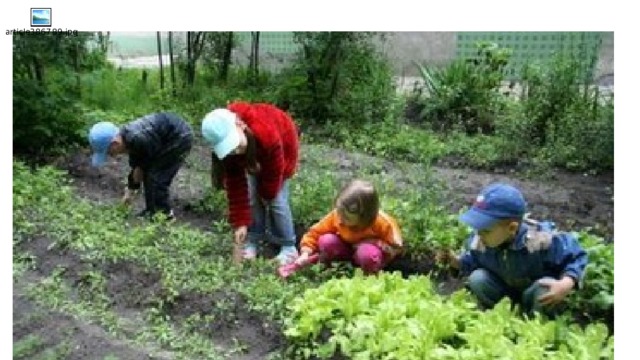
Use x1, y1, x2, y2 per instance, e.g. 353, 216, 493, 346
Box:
456, 32, 602, 79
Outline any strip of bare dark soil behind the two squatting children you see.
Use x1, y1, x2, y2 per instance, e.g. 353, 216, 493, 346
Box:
310, 146, 614, 239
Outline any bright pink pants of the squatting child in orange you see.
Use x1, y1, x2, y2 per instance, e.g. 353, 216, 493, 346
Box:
318, 234, 385, 274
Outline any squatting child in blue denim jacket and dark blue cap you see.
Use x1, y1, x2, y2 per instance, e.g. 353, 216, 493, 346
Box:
440, 183, 587, 315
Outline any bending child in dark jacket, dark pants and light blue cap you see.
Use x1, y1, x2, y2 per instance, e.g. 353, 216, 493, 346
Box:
89, 112, 193, 218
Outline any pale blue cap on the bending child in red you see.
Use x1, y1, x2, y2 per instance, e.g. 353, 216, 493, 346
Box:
202, 109, 240, 159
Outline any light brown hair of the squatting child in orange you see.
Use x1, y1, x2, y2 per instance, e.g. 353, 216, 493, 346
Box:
335, 180, 380, 226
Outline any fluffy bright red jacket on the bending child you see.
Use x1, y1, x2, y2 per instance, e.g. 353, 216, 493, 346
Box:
224, 102, 299, 228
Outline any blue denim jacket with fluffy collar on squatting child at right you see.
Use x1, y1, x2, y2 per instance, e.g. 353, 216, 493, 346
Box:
460, 223, 587, 290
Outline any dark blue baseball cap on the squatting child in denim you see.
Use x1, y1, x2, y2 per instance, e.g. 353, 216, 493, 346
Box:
460, 183, 527, 230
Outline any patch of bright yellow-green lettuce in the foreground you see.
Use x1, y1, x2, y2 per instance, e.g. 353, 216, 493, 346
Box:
285, 272, 613, 360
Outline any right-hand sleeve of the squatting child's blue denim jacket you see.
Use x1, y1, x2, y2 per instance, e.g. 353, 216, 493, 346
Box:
547, 233, 588, 288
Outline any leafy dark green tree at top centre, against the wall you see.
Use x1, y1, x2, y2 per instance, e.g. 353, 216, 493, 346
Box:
277, 32, 395, 125
